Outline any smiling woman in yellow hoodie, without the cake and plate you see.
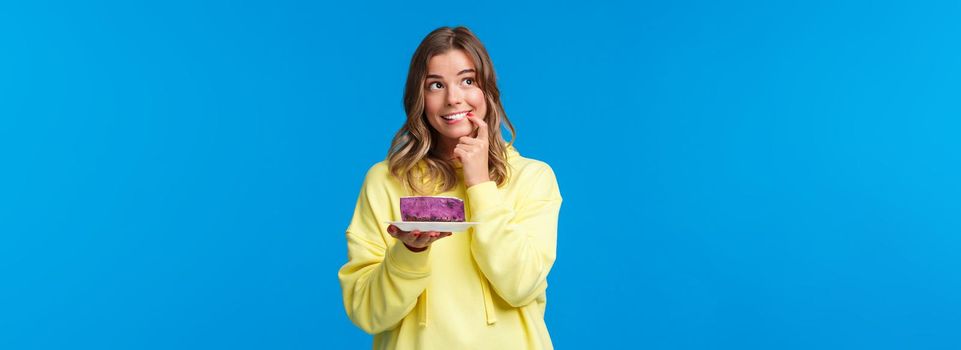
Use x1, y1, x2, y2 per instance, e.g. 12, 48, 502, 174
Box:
338, 27, 561, 350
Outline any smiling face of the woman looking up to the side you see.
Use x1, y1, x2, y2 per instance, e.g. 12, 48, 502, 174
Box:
424, 49, 487, 144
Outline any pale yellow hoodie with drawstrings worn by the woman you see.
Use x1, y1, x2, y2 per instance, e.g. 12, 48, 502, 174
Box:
338, 147, 561, 350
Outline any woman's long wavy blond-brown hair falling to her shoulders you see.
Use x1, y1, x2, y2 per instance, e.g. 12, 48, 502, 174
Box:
387, 27, 516, 195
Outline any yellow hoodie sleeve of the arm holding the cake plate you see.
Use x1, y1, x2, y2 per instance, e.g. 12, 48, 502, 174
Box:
338, 165, 430, 334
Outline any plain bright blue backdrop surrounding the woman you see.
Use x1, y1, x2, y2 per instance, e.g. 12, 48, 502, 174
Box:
0, 1, 961, 349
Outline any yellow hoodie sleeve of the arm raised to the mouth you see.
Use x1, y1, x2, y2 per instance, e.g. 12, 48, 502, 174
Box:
467, 164, 561, 307
